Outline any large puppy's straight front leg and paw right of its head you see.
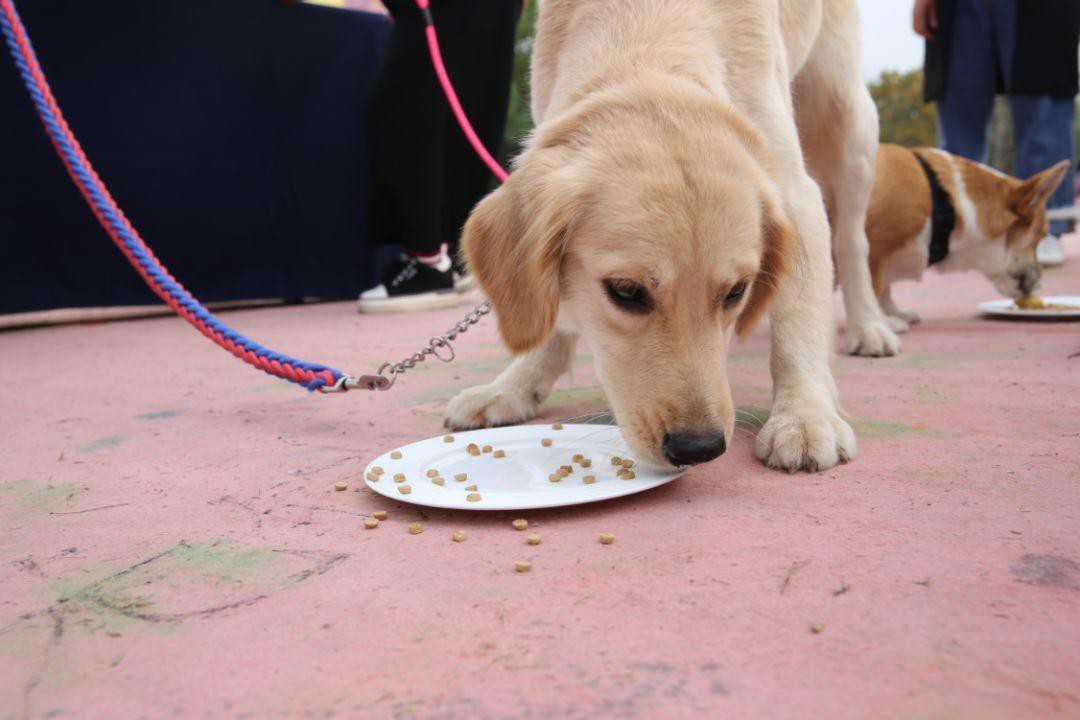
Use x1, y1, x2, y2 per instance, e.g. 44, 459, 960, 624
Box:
756, 175, 856, 472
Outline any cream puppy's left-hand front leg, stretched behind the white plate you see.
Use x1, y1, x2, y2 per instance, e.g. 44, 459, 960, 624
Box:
446, 329, 578, 430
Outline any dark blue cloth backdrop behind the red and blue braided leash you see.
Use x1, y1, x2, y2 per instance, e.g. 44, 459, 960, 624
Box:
0, 0, 390, 313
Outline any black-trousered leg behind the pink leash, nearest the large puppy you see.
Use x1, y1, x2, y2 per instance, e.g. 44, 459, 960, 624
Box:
433, 0, 522, 280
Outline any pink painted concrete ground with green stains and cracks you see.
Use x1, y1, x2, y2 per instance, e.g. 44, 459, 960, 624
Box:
0, 239, 1080, 720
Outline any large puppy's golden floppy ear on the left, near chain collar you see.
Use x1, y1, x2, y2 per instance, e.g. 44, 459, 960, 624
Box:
461, 149, 575, 353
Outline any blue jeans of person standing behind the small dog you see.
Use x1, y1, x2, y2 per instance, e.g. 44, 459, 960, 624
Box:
937, 0, 1076, 235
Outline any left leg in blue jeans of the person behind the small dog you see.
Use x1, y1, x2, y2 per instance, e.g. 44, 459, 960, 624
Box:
937, 0, 998, 162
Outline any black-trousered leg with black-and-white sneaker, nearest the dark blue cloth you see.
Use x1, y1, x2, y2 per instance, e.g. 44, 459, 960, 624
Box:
359, 0, 457, 312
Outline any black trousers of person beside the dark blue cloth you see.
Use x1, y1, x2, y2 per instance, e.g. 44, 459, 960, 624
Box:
368, 0, 521, 254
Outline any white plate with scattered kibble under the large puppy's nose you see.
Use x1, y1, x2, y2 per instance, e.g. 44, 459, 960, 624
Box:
364, 425, 681, 510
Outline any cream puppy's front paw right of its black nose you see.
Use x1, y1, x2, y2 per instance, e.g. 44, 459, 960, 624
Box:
755, 403, 859, 473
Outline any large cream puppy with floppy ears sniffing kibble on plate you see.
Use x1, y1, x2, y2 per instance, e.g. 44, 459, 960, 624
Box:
447, 0, 899, 471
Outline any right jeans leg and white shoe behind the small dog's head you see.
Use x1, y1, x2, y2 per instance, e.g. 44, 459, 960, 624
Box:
1009, 95, 1076, 264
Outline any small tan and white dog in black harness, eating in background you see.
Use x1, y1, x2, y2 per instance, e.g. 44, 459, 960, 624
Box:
866, 145, 1069, 332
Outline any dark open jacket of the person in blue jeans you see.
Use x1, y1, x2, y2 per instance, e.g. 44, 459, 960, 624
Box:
923, 0, 1080, 103
